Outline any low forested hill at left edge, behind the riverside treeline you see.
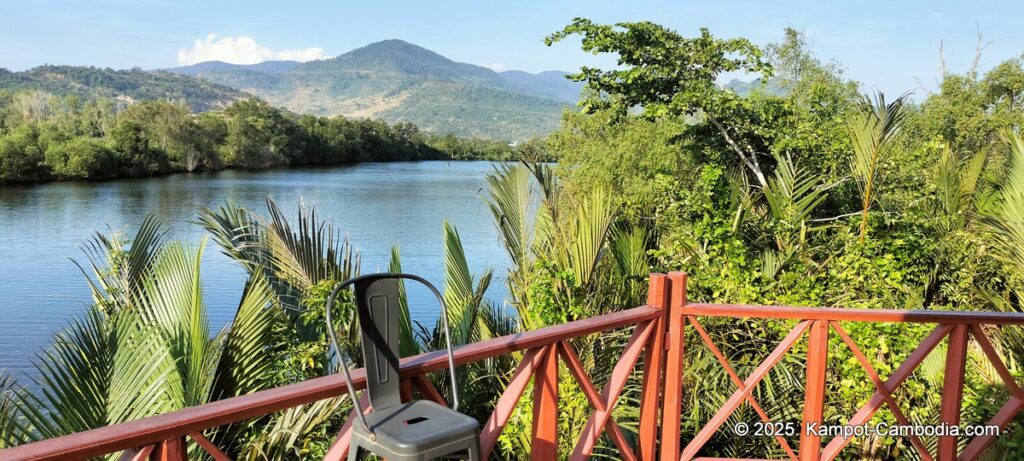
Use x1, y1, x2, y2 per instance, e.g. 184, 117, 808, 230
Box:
0, 66, 246, 112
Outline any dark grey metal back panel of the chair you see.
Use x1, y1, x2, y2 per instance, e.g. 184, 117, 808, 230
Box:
353, 274, 401, 410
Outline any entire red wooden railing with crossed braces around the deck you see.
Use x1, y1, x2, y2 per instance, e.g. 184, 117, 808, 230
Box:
0, 273, 1024, 461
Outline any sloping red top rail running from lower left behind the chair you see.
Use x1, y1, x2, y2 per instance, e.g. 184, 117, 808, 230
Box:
0, 306, 663, 461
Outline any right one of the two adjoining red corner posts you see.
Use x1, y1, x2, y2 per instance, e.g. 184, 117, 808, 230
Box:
662, 273, 686, 461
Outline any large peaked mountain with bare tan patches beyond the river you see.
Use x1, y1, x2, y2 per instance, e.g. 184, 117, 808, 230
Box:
167, 40, 581, 140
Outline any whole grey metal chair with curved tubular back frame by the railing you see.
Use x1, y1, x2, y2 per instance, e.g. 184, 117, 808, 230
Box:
327, 273, 480, 461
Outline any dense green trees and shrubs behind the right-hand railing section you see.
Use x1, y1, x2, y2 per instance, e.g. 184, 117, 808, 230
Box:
544, 19, 1024, 459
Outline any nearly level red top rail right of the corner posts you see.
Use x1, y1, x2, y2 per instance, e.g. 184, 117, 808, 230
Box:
682, 302, 1024, 325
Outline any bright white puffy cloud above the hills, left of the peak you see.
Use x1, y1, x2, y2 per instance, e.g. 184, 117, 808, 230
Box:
178, 34, 324, 66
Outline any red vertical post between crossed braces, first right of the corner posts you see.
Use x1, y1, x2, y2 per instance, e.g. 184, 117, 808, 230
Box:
799, 321, 828, 461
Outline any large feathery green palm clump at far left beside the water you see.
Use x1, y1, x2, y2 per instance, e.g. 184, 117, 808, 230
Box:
0, 217, 294, 456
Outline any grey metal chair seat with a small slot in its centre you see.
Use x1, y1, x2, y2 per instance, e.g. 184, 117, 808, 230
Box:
355, 401, 480, 454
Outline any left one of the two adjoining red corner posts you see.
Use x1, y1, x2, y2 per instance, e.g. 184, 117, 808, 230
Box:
639, 274, 669, 461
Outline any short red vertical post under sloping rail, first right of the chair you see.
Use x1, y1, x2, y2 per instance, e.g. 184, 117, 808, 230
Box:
529, 345, 558, 461
